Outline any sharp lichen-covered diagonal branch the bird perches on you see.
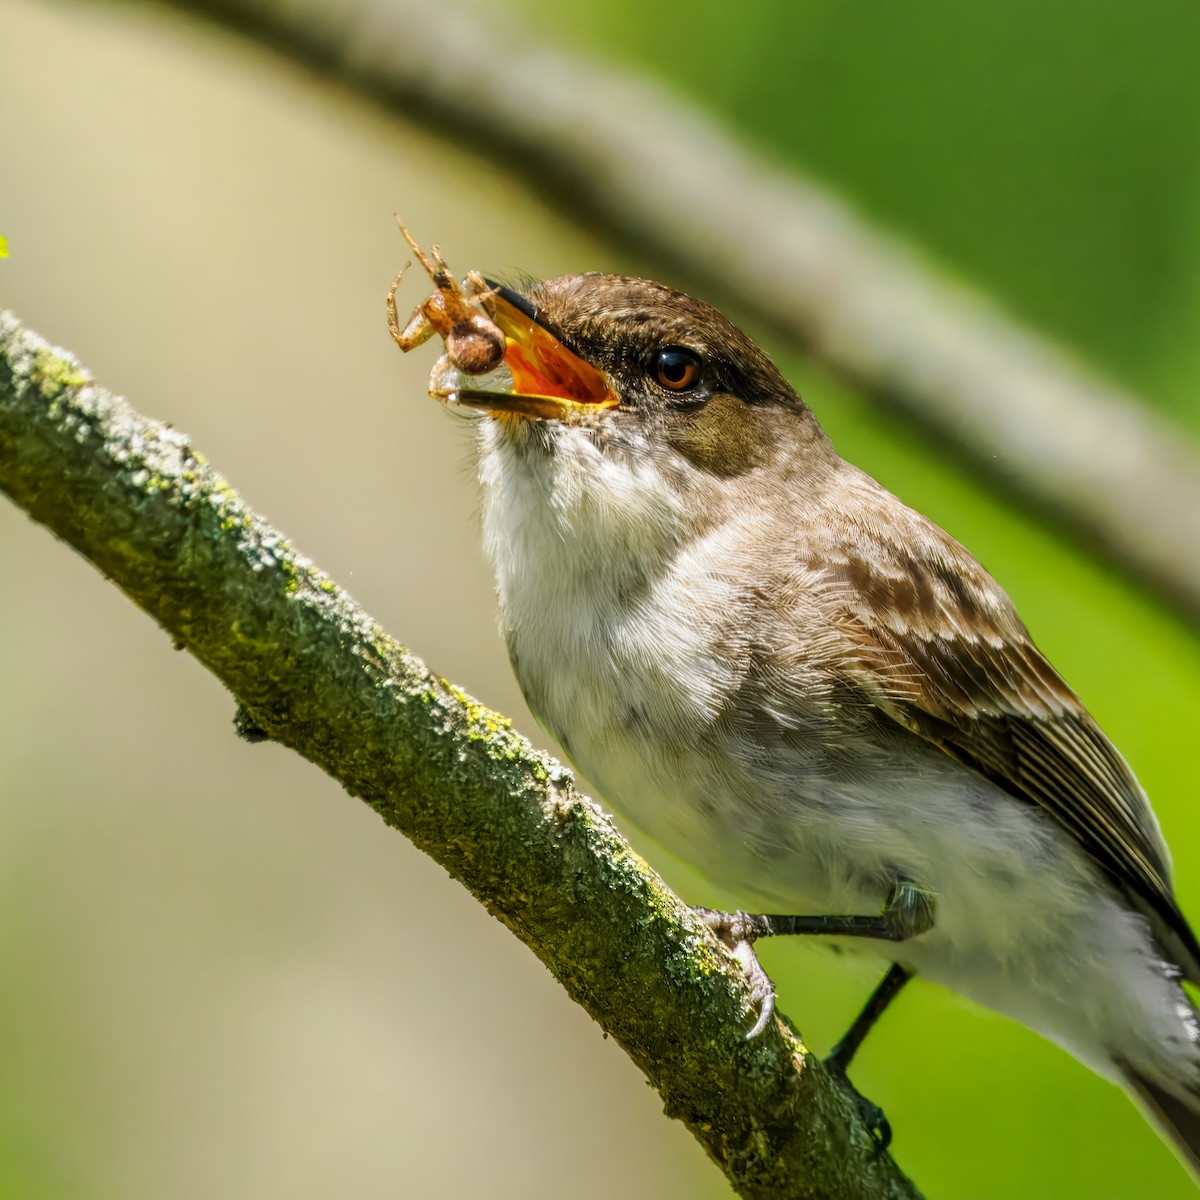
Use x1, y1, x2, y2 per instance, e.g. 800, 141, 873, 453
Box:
0, 313, 917, 1200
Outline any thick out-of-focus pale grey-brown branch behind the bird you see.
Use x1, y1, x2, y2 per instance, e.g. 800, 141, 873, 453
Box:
171, 0, 1200, 626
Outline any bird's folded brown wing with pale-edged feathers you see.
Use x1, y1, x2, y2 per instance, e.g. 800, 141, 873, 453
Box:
820, 502, 1200, 977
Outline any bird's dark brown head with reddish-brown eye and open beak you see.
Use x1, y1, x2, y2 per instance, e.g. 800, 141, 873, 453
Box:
443, 274, 828, 504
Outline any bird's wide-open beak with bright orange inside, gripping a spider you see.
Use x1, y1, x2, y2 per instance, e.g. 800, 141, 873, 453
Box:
430, 280, 619, 420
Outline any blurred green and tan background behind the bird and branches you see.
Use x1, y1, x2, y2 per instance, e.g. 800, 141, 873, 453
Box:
0, 0, 1200, 1200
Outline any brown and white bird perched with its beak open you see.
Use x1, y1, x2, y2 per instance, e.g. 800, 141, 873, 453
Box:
389, 260, 1200, 1177
